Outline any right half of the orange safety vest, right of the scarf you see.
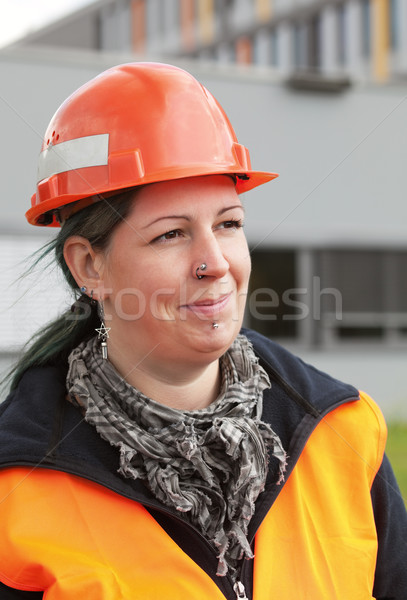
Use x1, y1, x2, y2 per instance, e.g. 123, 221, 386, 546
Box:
254, 394, 387, 600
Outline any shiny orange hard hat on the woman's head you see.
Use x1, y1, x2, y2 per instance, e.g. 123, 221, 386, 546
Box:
26, 63, 277, 226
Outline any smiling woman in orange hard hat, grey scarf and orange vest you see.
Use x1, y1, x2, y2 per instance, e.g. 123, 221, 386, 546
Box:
0, 63, 407, 600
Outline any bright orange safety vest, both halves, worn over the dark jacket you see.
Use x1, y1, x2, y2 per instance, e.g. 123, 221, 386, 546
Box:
0, 395, 386, 600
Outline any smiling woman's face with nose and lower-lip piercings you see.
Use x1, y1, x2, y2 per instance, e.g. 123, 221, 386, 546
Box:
101, 175, 250, 376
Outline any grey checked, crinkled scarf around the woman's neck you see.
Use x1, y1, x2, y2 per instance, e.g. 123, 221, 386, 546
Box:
67, 335, 286, 577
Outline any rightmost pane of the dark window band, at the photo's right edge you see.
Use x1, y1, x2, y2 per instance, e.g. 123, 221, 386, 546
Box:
316, 250, 407, 343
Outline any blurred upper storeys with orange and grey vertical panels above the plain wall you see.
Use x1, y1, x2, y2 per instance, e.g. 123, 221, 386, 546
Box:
10, 0, 407, 82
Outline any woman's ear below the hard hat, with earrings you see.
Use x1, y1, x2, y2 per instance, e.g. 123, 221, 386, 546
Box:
64, 235, 104, 300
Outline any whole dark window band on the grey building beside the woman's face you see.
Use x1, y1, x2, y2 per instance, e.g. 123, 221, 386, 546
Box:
245, 248, 407, 347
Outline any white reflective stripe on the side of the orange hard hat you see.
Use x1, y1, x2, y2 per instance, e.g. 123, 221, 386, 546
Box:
38, 133, 109, 181
